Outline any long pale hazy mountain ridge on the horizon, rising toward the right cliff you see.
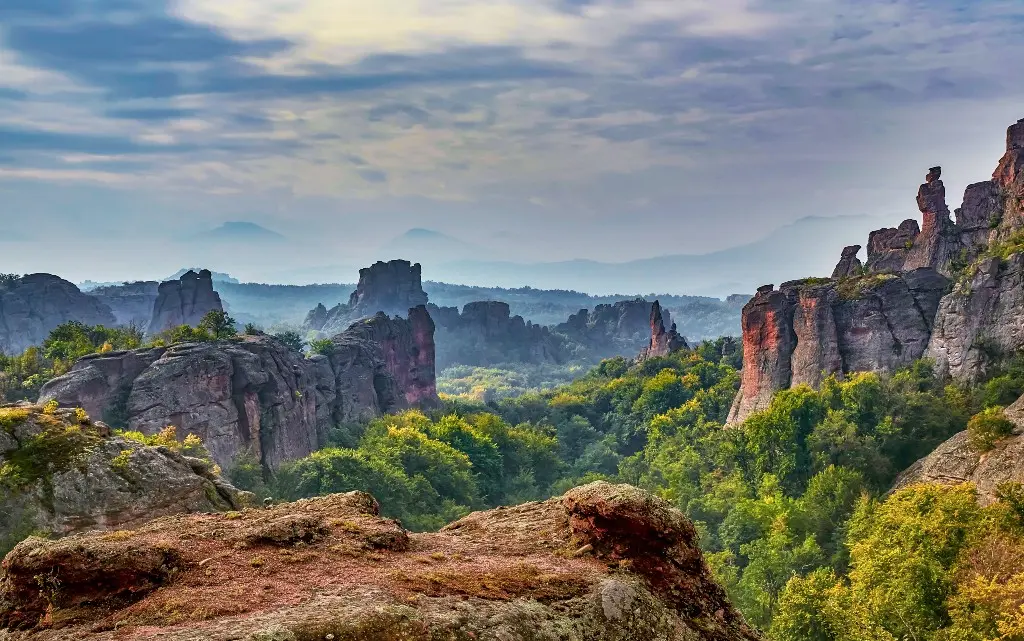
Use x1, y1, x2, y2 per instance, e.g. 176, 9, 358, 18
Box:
424, 216, 899, 297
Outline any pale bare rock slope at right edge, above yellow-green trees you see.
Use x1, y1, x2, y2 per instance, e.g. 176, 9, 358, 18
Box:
893, 387, 1024, 504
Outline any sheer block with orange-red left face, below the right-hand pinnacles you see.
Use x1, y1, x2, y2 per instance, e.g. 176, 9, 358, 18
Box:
729, 268, 948, 422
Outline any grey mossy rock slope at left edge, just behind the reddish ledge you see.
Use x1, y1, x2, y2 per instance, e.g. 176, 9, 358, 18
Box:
0, 404, 252, 551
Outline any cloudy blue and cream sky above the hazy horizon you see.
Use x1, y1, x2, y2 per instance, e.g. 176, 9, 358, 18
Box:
0, 0, 1024, 281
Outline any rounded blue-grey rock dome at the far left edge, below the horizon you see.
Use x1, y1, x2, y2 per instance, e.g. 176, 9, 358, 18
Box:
0, 273, 117, 354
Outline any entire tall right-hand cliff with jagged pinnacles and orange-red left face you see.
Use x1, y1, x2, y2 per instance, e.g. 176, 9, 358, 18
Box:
731, 120, 1024, 421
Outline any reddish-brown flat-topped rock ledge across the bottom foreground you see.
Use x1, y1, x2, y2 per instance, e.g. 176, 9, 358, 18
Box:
0, 482, 757, 641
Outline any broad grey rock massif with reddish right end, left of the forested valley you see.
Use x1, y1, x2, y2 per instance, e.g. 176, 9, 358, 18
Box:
40, 307, 437, 468
